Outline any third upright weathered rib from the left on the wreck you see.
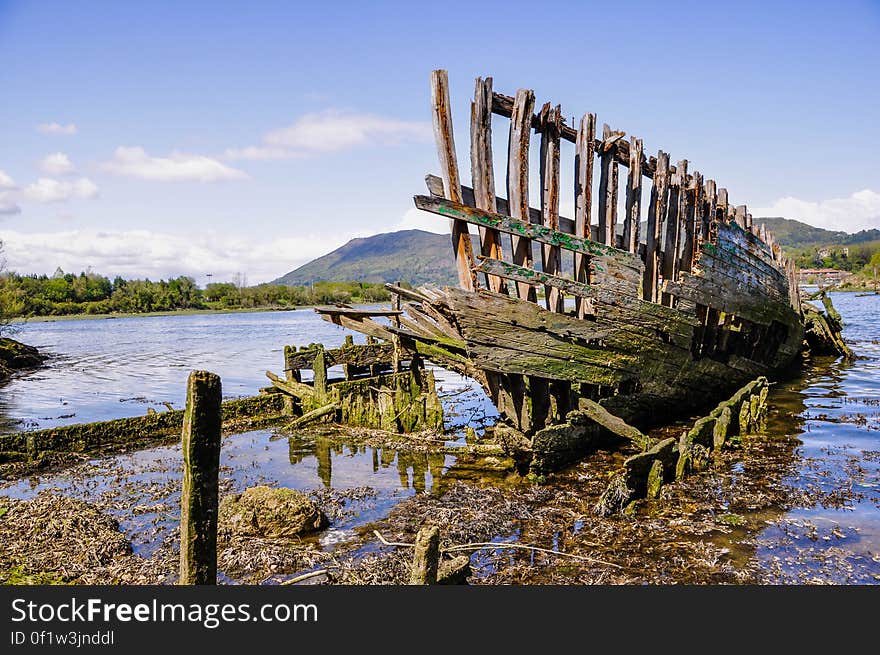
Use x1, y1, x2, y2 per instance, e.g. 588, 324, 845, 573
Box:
507, 89, 537, 302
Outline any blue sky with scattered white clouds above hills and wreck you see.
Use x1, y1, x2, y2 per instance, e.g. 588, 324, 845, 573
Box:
0, 0, 880, 284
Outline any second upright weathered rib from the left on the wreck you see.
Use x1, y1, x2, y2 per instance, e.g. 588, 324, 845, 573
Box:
465, 77, 507, 293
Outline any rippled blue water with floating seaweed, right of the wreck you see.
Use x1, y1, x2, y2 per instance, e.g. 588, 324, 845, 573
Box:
757, 293, 880, 583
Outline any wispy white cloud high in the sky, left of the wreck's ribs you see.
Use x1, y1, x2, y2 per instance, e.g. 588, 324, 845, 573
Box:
226, 109, 431, 159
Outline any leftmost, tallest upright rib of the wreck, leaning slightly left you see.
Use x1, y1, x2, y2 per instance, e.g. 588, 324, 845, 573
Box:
431, 70, 477, 291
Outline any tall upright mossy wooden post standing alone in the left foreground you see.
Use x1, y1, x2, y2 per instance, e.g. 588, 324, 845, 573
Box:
180, 371, 223, 585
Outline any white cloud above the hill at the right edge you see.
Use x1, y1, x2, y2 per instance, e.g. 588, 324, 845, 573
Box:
751, 189, 880, 232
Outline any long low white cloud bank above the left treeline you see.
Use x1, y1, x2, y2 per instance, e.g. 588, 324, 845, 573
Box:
0, 229, 350, 285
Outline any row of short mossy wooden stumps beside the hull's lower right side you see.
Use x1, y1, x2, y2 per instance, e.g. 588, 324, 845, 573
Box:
595, 376, 770, 516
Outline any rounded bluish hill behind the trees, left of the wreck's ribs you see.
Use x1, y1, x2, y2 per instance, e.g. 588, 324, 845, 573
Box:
272, 230, 457, 286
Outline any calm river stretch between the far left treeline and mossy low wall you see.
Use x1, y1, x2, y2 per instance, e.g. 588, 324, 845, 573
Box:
0, 309, 494, 430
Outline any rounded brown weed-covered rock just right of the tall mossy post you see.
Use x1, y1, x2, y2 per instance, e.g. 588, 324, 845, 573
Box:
219, 486, 328, 539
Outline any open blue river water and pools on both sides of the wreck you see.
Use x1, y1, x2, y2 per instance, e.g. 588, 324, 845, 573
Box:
0, 293, 880, 583
